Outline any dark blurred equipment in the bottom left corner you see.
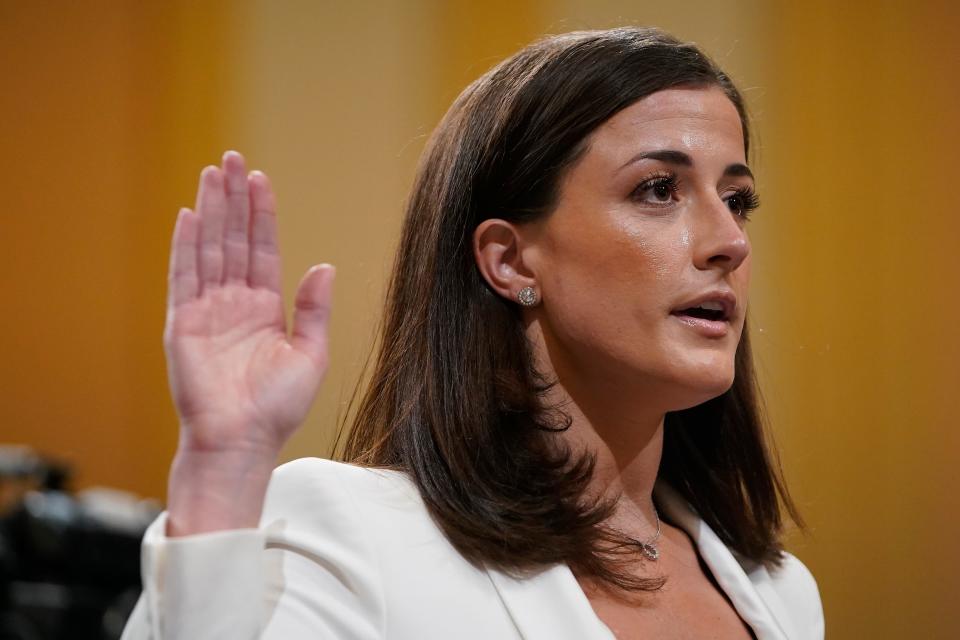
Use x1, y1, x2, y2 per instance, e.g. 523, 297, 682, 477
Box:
0, 447, 160, 640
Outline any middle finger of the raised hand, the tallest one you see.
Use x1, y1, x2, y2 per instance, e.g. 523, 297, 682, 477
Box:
223, 151, 250, 284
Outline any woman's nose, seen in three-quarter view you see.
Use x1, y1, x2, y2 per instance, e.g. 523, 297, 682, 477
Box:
694, 195, 750, 273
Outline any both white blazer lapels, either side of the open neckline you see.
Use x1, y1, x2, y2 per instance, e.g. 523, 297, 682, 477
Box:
487, 481, 793, 640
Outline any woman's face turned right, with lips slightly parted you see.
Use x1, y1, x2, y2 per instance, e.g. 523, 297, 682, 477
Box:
523, 88, 756, 411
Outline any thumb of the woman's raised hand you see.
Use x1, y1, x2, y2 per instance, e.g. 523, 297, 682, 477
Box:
290, 264, 336, 369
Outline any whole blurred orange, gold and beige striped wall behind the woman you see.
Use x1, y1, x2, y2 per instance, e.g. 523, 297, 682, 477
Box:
0, 0, 960, 639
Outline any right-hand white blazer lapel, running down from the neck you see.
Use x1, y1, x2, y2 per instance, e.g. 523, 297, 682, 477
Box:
654, 481, 795, 640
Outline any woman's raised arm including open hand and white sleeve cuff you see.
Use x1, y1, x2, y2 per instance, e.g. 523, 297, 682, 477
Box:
125, 152, 342, 640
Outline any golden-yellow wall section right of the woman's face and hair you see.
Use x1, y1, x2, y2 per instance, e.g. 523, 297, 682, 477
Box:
757, 2, 960, 638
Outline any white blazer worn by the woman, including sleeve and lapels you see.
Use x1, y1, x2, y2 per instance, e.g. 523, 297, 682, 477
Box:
122, 458, 824, 640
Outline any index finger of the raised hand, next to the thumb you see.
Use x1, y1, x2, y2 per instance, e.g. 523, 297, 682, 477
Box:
248, 171, 281, 294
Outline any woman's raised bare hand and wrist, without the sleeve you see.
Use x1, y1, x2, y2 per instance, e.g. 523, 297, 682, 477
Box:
163, 152, 333, 536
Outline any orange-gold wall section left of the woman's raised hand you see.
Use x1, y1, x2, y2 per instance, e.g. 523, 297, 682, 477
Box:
0, 1, 233, 504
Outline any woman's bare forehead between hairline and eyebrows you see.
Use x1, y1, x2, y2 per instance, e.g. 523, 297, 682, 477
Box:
590, 87, 745, 162
